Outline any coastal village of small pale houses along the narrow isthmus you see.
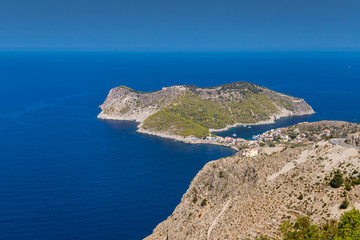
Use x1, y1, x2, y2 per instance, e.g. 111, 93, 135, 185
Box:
186, 125, 331, 157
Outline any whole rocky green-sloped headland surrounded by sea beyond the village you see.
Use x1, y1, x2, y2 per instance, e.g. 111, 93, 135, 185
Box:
98, 82, 314, 138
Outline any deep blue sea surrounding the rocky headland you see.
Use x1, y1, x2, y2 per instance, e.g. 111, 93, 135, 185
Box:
0, 52, 360, 240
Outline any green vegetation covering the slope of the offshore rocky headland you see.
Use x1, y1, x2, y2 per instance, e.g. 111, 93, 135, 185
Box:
142, 87, 284, 138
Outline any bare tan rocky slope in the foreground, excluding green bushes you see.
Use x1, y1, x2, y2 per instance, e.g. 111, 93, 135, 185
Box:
146, 141, 360, 240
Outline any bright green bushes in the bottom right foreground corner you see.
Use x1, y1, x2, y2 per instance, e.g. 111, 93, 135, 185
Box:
280, 208, 360, 240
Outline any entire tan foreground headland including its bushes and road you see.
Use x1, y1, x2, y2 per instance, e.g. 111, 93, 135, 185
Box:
145, 121, 360, 240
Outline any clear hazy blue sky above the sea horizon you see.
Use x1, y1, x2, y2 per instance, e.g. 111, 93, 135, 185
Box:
0, 0, 360, 51
